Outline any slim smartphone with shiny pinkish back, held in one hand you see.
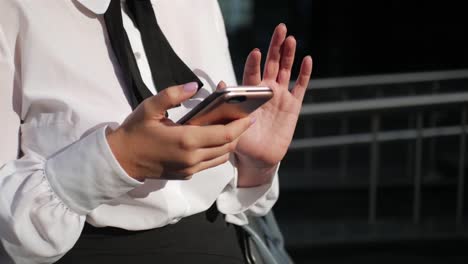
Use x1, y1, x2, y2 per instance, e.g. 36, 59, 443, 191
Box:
177, 86, 273, 126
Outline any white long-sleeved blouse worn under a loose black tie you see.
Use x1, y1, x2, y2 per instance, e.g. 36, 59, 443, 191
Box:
0, 0, 279, 264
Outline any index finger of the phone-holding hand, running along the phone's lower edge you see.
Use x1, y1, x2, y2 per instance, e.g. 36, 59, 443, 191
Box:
187, 116, 254, 148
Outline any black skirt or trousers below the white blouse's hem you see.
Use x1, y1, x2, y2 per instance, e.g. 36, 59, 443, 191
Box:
57, 209, 245, 264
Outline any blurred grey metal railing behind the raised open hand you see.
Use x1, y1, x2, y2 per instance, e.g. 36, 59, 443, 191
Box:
282, 70, 468, 245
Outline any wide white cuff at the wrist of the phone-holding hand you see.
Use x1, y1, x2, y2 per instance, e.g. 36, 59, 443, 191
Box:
45, 126, 143, 214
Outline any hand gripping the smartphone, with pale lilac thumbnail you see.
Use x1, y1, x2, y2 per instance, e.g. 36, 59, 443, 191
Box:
107, 83, 252, 181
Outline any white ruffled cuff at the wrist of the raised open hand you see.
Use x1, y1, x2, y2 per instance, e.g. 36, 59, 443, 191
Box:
217, 160, 279, 225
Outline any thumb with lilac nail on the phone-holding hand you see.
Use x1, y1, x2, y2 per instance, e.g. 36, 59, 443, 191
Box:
149, 82, 198, 114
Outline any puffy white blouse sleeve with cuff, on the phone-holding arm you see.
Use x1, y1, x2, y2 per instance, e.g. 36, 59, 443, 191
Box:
0, 1, 141, 264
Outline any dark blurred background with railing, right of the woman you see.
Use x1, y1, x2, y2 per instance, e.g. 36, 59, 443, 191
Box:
219, 0, 468, 263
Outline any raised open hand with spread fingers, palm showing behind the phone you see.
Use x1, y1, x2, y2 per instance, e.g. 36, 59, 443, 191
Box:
235, 24, 312, 187
